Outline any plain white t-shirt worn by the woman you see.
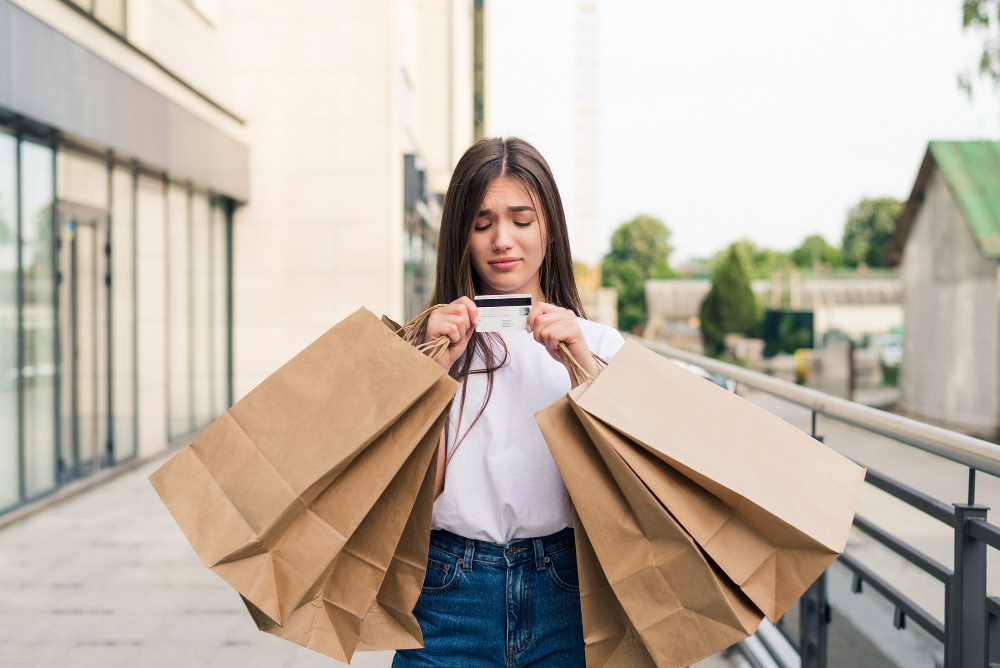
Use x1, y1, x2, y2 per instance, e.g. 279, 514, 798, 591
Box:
431, 318, 625, 544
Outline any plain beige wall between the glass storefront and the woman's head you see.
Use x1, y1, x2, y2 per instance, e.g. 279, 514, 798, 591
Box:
221, 0, 472, 398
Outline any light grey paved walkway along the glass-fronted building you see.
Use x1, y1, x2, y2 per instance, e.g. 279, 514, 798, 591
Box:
0, 452, 731, 668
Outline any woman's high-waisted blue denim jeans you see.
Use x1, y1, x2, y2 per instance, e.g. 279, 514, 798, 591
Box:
392, 527, 586, 668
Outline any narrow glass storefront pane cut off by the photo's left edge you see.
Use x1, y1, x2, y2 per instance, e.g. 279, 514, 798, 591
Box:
0, 133, 21, 509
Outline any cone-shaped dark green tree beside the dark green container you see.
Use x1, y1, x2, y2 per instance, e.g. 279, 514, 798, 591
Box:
698, 242, 760, 356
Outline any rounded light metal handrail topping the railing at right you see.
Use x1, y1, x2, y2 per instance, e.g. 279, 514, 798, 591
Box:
626, 334, 1000, 477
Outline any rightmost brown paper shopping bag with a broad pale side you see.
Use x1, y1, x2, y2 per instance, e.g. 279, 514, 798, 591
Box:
570, 341, 864, 620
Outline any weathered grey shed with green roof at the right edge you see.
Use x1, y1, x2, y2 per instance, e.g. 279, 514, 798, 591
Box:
889, 142, 1000, 439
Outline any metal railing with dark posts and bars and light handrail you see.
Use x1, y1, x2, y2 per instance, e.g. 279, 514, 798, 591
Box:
635, 338, 1000, 668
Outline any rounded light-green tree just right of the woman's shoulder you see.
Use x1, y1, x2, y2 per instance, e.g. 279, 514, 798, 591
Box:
601, 216, 677, 331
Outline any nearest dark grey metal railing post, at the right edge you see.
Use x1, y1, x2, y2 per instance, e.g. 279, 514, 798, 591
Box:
945, 503, 989, 668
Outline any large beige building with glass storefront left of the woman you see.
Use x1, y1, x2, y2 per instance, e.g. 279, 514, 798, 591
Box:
0, 0, 483, 512
